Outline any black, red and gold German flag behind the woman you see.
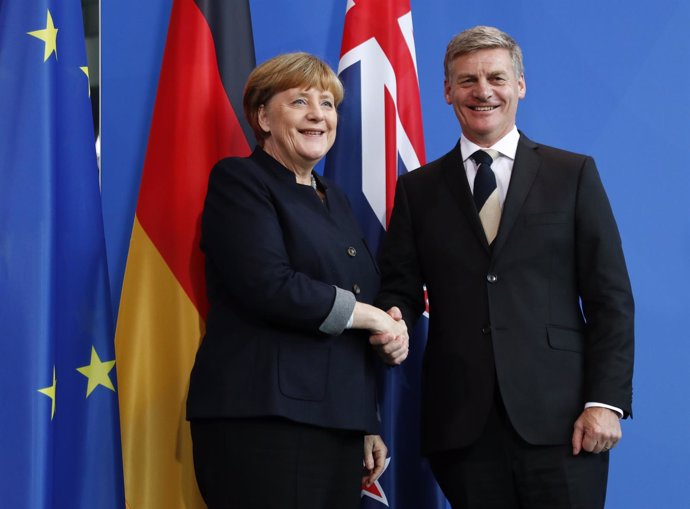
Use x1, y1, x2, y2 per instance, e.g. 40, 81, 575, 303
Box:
115, 0, 255, 509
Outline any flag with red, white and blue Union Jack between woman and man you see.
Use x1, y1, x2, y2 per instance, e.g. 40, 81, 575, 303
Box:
324, 0, 446, 509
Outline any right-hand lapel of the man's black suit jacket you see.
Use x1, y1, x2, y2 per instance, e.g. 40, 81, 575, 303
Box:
492, 133, 541, 256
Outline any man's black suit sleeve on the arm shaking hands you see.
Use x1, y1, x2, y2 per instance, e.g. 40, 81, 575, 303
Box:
375, 177, 426, 330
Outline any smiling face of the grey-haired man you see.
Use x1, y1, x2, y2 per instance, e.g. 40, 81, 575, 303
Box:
444, 48, 526, 147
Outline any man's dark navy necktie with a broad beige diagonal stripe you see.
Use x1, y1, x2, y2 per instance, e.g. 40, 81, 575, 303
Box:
470, 149, 501, 244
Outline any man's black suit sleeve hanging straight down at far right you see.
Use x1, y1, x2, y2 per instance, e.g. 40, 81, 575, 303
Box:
575, 158, 634, 416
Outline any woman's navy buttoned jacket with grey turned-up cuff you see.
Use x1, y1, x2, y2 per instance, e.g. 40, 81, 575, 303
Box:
187, 149, 378, 432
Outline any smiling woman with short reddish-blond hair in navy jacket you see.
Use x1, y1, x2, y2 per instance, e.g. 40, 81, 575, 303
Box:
187, 53, 408, 509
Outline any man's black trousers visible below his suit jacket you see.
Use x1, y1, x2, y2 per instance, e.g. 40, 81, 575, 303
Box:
429, 395, 609, 509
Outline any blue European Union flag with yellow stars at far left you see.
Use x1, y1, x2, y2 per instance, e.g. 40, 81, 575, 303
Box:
0, 0, 124, 509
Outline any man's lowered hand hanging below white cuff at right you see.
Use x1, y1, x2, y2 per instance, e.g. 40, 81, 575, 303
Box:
572, 407, 623, 456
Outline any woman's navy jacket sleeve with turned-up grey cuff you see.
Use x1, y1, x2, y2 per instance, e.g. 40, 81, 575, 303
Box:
202, 160, 355, 333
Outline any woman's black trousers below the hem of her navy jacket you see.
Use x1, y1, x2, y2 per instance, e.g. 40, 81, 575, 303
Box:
191, 417, 364, 509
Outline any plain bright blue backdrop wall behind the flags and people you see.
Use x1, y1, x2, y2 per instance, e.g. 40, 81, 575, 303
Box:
101, 0, 690, 509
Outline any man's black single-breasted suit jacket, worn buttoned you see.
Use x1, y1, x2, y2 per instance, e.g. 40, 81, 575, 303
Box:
377, 135, 633, 453
